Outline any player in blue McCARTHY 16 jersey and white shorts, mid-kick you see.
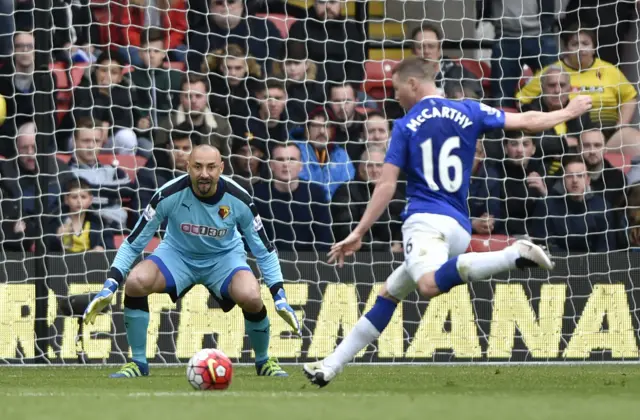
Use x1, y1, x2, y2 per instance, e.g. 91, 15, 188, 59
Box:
303, 58, 591, 387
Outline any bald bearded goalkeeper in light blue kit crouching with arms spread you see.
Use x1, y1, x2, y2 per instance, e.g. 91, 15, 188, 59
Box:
84, 145, 300, 378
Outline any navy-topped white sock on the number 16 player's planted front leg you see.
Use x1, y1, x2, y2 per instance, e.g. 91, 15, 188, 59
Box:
322, 296, 397, 372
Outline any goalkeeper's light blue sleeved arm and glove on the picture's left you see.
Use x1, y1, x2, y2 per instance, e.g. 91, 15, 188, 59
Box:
83, 191, 168, 324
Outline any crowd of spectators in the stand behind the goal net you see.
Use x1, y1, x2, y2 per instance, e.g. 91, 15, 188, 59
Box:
0, 0, 640, 252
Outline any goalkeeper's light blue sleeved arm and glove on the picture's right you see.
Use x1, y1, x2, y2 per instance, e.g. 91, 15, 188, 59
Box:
239, 203, 300, 335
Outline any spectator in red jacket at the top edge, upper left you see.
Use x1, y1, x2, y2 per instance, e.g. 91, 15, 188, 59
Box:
108, 0, 187, 67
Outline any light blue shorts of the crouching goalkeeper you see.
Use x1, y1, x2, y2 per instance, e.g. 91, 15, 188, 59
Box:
147, 242, 251, 302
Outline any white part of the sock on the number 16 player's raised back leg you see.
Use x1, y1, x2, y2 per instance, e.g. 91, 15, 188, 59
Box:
457, 248, 520, 281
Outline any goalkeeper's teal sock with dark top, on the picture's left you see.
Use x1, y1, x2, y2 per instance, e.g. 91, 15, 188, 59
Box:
124, 294, 149, 363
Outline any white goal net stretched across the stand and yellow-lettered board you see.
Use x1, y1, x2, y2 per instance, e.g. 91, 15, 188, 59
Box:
0, 0, 640, 364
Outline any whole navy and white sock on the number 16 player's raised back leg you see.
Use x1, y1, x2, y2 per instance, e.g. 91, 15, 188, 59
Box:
435, 247, 520, 293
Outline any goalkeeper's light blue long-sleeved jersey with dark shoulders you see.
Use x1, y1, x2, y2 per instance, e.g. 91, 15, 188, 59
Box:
112, 175, 282, 286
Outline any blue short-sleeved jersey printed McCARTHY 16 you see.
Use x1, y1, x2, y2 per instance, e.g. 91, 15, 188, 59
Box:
385, 96, 505, 232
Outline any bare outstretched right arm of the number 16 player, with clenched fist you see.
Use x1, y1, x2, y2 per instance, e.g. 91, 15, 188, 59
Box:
504, 95, 591, 133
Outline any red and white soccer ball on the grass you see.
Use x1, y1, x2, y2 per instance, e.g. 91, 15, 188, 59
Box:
187, 349, 233, 391
